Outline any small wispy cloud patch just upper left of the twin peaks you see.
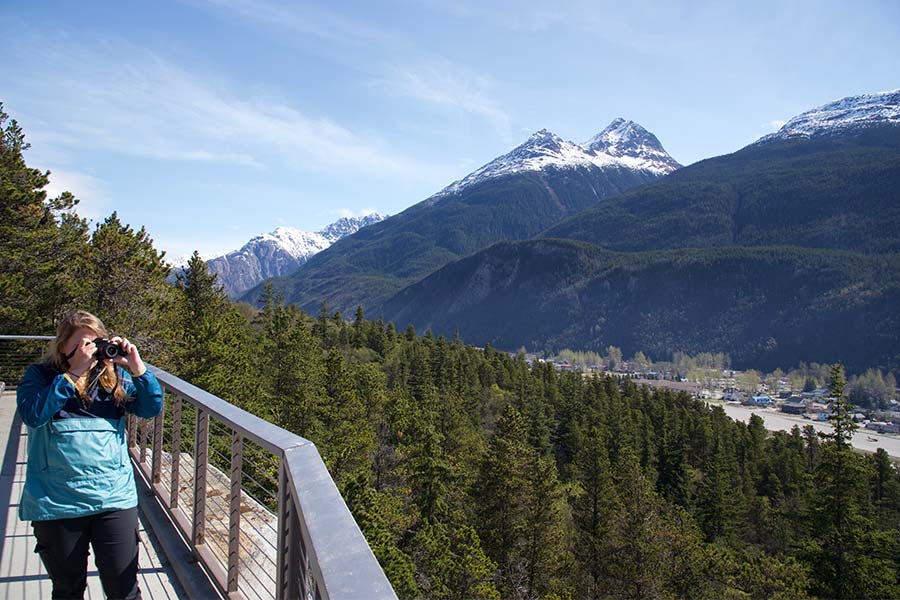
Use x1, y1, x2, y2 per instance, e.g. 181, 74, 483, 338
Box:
375, 60, 510, 135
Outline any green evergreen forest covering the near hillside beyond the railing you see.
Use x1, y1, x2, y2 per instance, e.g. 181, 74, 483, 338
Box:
0, 105, 900, 600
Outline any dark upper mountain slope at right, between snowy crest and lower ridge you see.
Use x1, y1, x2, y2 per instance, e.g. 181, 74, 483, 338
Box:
544, 93, 900, 253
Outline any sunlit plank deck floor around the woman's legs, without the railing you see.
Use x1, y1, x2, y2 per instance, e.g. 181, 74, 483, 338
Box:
0, 392, 187, 600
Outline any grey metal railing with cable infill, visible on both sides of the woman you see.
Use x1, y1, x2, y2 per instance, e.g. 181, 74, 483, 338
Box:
0, 336, 397, 600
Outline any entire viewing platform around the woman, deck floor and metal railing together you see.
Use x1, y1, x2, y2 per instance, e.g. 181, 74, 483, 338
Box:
0, 336, 397, 600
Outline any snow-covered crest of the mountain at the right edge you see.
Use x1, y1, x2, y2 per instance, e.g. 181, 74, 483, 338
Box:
757, 90, 900, 143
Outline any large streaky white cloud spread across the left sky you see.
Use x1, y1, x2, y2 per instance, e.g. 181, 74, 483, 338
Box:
10, 35, 428, 177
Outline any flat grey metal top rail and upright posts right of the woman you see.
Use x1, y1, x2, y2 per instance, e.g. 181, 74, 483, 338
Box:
144, 365, 397, 600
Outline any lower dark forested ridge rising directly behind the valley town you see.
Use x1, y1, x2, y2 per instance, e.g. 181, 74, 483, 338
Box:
384, 239, 900, 370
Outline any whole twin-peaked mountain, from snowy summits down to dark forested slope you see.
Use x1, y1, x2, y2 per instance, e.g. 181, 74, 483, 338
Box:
242, 119, 680, 313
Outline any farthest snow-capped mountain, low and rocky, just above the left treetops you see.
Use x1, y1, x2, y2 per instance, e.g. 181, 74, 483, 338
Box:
206, 213, 385, 297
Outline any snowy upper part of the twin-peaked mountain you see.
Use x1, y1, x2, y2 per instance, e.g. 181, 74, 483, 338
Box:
426, 118, 681, 204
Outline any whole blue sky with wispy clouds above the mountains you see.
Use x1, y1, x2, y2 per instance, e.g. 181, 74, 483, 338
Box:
0, 0, 900, 257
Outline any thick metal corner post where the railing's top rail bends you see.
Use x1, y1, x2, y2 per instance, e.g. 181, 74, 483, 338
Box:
275, 455, 308, 600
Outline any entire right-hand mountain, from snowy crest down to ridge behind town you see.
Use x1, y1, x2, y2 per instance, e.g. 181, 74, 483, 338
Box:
381, 91, 900, 370
